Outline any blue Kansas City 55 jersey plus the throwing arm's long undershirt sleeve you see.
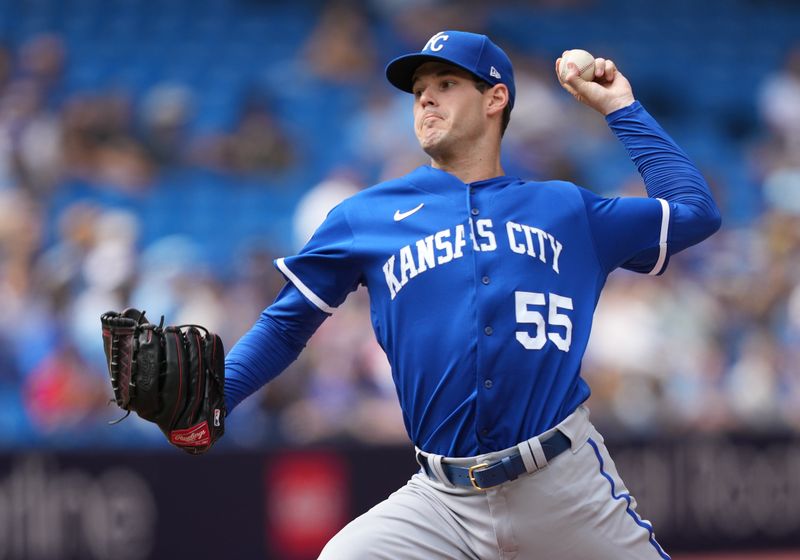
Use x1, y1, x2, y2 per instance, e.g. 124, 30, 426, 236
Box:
223, 103, 719, 456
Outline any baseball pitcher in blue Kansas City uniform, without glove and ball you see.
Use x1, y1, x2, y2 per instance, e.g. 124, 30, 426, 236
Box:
205, 31, 720, 560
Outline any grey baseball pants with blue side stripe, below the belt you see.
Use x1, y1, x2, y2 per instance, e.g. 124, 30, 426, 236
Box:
320, 407, 669, 560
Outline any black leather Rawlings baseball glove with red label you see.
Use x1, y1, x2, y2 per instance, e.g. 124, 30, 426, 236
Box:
100, 309, 225, 455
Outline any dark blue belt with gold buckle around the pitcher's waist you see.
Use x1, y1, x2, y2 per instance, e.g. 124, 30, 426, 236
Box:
417, 430, 572, 490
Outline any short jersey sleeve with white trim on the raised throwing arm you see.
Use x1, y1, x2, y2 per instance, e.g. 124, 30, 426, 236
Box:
581, 189, 673, 274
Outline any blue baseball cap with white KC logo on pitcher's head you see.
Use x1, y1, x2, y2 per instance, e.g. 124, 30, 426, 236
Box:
386, 31, 515, 107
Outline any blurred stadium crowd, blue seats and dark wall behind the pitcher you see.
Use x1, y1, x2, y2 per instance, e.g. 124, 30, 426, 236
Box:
0, 0, 800, 560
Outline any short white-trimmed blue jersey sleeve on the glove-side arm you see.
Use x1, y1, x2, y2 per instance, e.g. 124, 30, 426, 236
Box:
275, 204, 362, 314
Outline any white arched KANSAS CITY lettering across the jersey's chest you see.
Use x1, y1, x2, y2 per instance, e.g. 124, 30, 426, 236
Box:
383, 219, 564, 299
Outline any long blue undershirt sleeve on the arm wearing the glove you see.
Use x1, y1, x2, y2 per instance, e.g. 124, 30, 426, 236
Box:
225, 283, 329, 414
